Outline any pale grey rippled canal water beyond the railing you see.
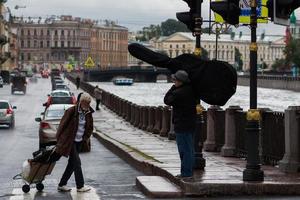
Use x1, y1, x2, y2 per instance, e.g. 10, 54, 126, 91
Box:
91, 82, 300, 111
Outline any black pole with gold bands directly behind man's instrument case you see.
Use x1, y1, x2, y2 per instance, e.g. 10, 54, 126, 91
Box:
193, 0, 205, 170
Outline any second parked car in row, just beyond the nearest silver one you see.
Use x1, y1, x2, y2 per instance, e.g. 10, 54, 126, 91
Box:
43, 90, 76, 108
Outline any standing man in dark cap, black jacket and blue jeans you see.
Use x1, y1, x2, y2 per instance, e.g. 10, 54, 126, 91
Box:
164, 70, 197, 179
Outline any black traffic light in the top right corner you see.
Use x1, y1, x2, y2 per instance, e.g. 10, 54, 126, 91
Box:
267, 0, 300, 25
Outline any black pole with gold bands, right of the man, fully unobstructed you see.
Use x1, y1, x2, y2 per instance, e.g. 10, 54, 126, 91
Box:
243, 0, 264, 181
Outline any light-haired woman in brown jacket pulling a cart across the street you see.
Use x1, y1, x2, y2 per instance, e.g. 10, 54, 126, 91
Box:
56, 93, 94, 192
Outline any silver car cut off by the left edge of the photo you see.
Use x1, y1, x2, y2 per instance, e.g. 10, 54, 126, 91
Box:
0, 100, 17, 128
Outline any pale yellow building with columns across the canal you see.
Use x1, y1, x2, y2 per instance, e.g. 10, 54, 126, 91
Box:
151, 32, 285, 71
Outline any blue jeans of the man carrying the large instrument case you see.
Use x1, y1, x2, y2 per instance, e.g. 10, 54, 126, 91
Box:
176, 132, 195, 177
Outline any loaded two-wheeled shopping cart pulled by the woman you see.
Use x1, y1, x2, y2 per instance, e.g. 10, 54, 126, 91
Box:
13, 147, 60, 193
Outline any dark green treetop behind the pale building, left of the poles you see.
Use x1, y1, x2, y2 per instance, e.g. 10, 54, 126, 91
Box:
161, 19, 190, 36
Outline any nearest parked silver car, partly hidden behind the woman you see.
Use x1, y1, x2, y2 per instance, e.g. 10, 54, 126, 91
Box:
35, 104, 74, 149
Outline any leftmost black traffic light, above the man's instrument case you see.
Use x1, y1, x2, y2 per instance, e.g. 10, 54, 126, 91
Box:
176, 0, 199, 32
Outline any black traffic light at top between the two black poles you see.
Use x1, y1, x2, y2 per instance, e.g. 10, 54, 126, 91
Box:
210, 0, 241, 25
